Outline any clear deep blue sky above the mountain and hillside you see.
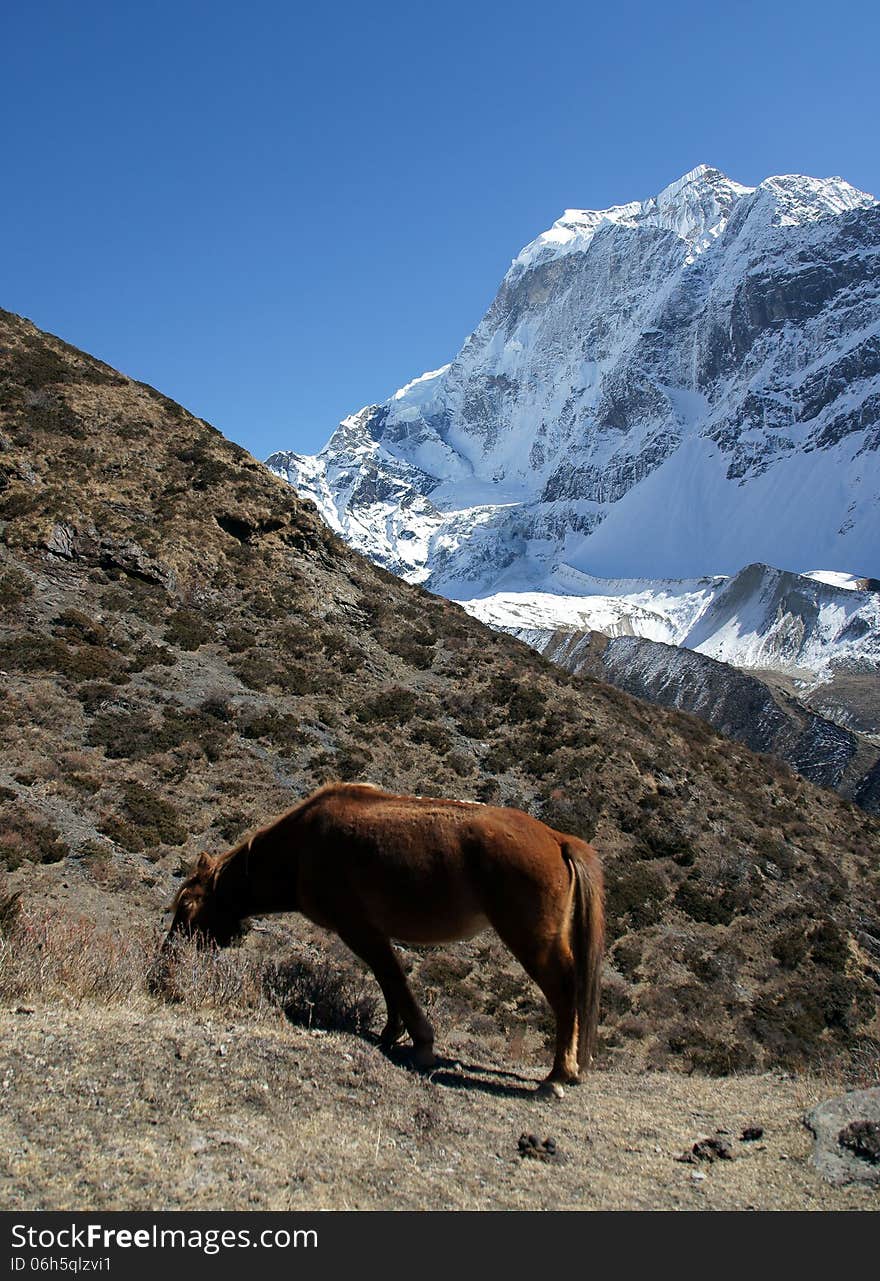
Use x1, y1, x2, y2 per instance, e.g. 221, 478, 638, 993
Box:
0, 0, 880, 456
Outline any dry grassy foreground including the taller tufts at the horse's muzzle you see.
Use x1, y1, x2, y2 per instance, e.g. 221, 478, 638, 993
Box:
0, 885, 875, 1211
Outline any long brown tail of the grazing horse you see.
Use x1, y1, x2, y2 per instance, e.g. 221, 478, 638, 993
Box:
562, 836, 605, 1072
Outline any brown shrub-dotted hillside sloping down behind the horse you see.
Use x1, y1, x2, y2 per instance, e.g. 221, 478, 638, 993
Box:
0, 304, 880, 1072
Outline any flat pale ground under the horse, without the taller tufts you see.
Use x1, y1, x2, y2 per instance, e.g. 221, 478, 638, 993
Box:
0, 1003, 880, 1211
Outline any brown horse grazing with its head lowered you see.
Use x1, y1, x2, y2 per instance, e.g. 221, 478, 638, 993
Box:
169, 783, 605, 1095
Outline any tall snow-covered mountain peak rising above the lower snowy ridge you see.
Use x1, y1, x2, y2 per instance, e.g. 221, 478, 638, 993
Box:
268, 165, 880, 596
